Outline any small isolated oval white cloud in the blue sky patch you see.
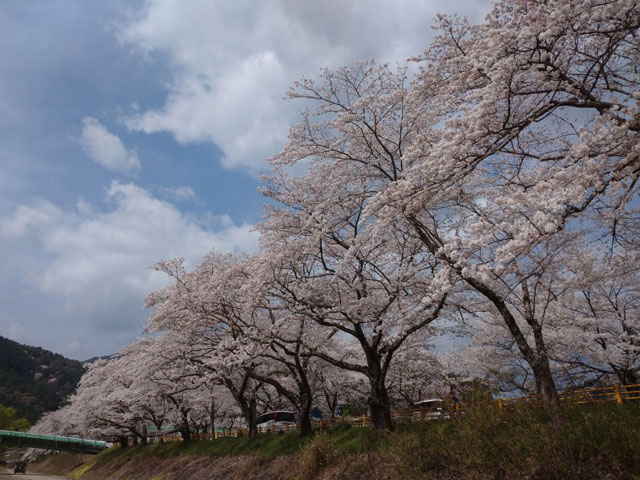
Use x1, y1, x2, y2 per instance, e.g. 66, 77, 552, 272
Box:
78, 117, 140, 175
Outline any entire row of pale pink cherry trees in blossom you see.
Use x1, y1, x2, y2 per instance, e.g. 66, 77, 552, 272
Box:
33, 0, 640, 439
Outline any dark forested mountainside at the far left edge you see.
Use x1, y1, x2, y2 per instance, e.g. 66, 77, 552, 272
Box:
0, 337, 84, 423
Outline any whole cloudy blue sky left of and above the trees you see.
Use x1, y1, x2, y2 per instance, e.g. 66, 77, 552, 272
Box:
0, 0, 489, 360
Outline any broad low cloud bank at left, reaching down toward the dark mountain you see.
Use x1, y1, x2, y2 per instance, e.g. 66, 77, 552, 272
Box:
0, 182, 257, 358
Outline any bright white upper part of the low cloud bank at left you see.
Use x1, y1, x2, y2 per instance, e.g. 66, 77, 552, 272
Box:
11, 182, 257, 294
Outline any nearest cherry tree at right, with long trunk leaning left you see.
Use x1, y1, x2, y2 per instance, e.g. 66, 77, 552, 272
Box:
396, 0, 640, 400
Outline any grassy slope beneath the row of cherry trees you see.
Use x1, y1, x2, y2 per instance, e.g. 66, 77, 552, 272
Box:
37, 404, 640, 480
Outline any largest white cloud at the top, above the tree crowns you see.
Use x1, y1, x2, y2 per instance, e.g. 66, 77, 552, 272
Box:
120, 0, 489, 171
